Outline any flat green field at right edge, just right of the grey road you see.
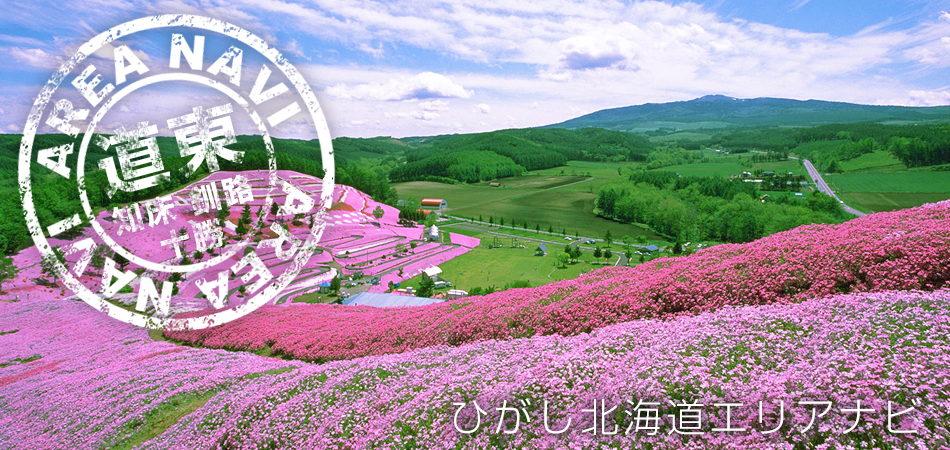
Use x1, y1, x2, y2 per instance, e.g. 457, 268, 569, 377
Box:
825, 171, 950, 212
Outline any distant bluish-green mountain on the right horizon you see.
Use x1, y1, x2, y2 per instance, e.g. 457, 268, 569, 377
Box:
545, 95, 950, 132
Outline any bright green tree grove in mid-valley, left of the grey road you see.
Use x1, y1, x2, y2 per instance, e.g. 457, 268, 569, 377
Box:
595, 171, 844, 243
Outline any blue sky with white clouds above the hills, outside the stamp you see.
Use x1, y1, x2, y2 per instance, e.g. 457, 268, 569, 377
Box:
0, 0, 950, 138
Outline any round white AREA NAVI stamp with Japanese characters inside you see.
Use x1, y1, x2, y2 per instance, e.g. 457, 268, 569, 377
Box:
19, 15, 334, 329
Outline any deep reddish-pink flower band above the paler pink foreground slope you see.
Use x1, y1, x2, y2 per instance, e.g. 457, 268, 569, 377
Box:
165, 202, 950, 361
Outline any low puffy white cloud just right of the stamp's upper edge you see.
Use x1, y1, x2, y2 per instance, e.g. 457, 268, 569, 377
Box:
326, 72, 474, 101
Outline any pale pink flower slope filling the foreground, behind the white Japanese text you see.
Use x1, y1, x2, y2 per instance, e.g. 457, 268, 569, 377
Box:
0, 284, 950, 450
